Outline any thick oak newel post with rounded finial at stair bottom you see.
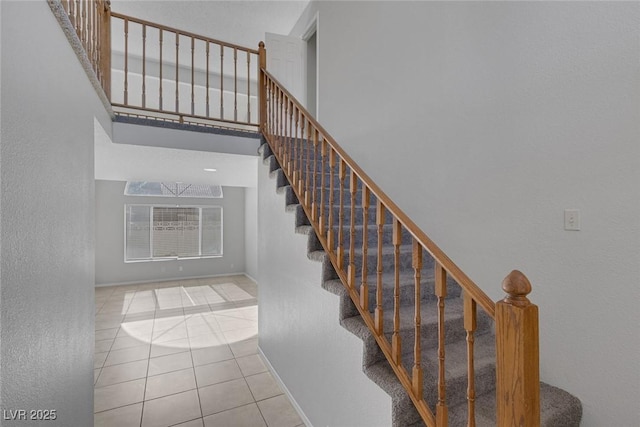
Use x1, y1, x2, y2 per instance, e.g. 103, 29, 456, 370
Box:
496, 270, 540, 427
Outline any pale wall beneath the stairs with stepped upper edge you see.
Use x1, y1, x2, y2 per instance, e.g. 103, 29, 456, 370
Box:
258, 155, 391, 427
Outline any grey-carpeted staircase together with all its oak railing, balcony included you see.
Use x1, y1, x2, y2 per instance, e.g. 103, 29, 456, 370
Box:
50, 0, 582, 427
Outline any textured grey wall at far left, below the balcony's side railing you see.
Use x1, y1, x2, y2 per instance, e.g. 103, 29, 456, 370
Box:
0, 1, 110, 426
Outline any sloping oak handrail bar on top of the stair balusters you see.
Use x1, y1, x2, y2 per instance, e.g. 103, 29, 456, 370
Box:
261, 68, 495, 318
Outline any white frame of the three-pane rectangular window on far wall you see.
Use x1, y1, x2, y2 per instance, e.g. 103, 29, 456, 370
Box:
122, 203, 224, 264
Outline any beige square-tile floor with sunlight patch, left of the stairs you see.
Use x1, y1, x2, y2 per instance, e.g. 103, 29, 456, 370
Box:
94, 276, 304, 427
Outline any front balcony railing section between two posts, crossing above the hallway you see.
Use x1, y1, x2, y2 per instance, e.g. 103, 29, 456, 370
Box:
110, 13, 259, 126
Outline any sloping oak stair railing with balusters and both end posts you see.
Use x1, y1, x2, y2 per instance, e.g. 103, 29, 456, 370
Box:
259, 55, 540, 427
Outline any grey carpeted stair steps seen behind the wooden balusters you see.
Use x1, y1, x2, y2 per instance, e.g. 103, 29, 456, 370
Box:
261, 144, 582, 427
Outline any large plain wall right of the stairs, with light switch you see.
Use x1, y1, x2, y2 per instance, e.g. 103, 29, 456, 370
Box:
290, 2, 640, 427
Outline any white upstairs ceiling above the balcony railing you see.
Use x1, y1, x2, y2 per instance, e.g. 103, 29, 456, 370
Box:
111, 0, 309, 49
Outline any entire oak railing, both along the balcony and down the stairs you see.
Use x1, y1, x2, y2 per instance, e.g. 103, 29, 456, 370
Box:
61, 0, 540, 427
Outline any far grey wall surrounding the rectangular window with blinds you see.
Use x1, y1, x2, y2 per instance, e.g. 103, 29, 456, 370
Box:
95, 180, 245, 285
